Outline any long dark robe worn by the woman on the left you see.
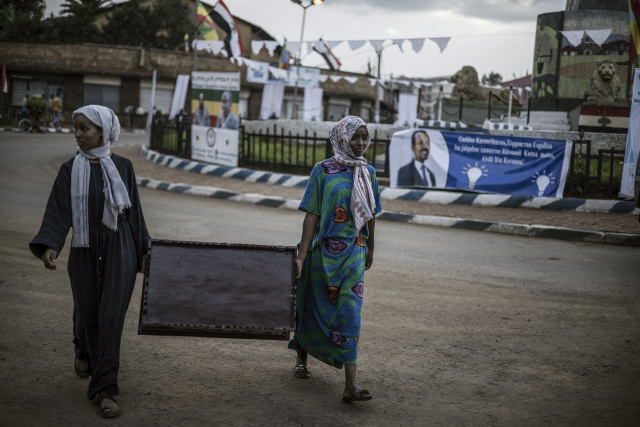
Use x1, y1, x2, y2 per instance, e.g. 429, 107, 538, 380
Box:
29, 154, 149, 399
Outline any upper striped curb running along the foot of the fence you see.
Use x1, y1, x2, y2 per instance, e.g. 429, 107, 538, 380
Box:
140, 146, 640, 214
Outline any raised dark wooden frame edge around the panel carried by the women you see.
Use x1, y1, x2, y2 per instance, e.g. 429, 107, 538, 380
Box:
138, 239, 297, 340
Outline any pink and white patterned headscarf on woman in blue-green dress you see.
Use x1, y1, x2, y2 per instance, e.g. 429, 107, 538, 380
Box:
329, 116, 376, 232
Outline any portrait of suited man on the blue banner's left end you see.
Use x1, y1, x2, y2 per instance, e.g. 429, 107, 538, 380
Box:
389, 129, 449, 188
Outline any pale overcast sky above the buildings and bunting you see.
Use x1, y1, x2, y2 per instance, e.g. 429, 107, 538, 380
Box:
47, 0, 566, 80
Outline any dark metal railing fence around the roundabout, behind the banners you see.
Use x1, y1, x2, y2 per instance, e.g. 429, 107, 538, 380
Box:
150, 119, 624, 198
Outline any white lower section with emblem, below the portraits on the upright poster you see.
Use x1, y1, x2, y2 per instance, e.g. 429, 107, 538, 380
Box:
191, 125, 238, 167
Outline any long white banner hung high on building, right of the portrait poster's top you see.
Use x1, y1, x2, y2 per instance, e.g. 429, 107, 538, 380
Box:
247, 61, 320, 87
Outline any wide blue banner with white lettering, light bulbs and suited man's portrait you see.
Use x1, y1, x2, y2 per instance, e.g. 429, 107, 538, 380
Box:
389, 129, 572, 197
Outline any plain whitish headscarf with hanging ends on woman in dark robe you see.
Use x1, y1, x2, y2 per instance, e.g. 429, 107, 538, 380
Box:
71, 105, 131, 248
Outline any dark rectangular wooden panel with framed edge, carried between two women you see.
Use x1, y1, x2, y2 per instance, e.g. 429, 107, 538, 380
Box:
138, 240, 296, 340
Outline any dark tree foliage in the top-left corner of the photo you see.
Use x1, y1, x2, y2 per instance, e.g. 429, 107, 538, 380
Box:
0, 0, 50, 41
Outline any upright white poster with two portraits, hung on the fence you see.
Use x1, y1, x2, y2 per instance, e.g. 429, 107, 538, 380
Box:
191, 71, 240, 167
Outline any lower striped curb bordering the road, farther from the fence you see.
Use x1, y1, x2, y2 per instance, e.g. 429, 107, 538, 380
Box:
137, 176, 640, 247
